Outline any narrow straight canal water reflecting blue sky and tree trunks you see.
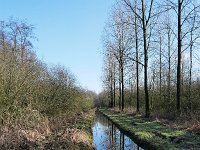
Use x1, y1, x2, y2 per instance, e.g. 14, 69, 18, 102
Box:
92, 112, 143, 150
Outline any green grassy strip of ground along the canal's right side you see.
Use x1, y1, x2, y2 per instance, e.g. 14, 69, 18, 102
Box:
99, 109, 200, 149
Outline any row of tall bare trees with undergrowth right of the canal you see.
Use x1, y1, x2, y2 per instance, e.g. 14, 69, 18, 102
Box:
97, 0, 200, 118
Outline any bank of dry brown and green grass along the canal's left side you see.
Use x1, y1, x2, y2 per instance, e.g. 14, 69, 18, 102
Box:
0, 109, 95, 150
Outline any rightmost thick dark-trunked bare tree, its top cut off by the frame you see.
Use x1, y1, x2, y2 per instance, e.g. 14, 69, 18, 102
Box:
166, 0, 200, 113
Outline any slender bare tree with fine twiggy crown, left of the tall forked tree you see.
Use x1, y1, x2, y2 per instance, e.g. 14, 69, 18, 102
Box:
104, 7, 133, 111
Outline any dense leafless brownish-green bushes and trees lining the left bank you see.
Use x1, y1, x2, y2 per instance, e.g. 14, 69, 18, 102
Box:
0, 19, 95, 148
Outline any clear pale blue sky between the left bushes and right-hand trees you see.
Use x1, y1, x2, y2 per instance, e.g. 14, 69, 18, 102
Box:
0, 0, 115, 92
